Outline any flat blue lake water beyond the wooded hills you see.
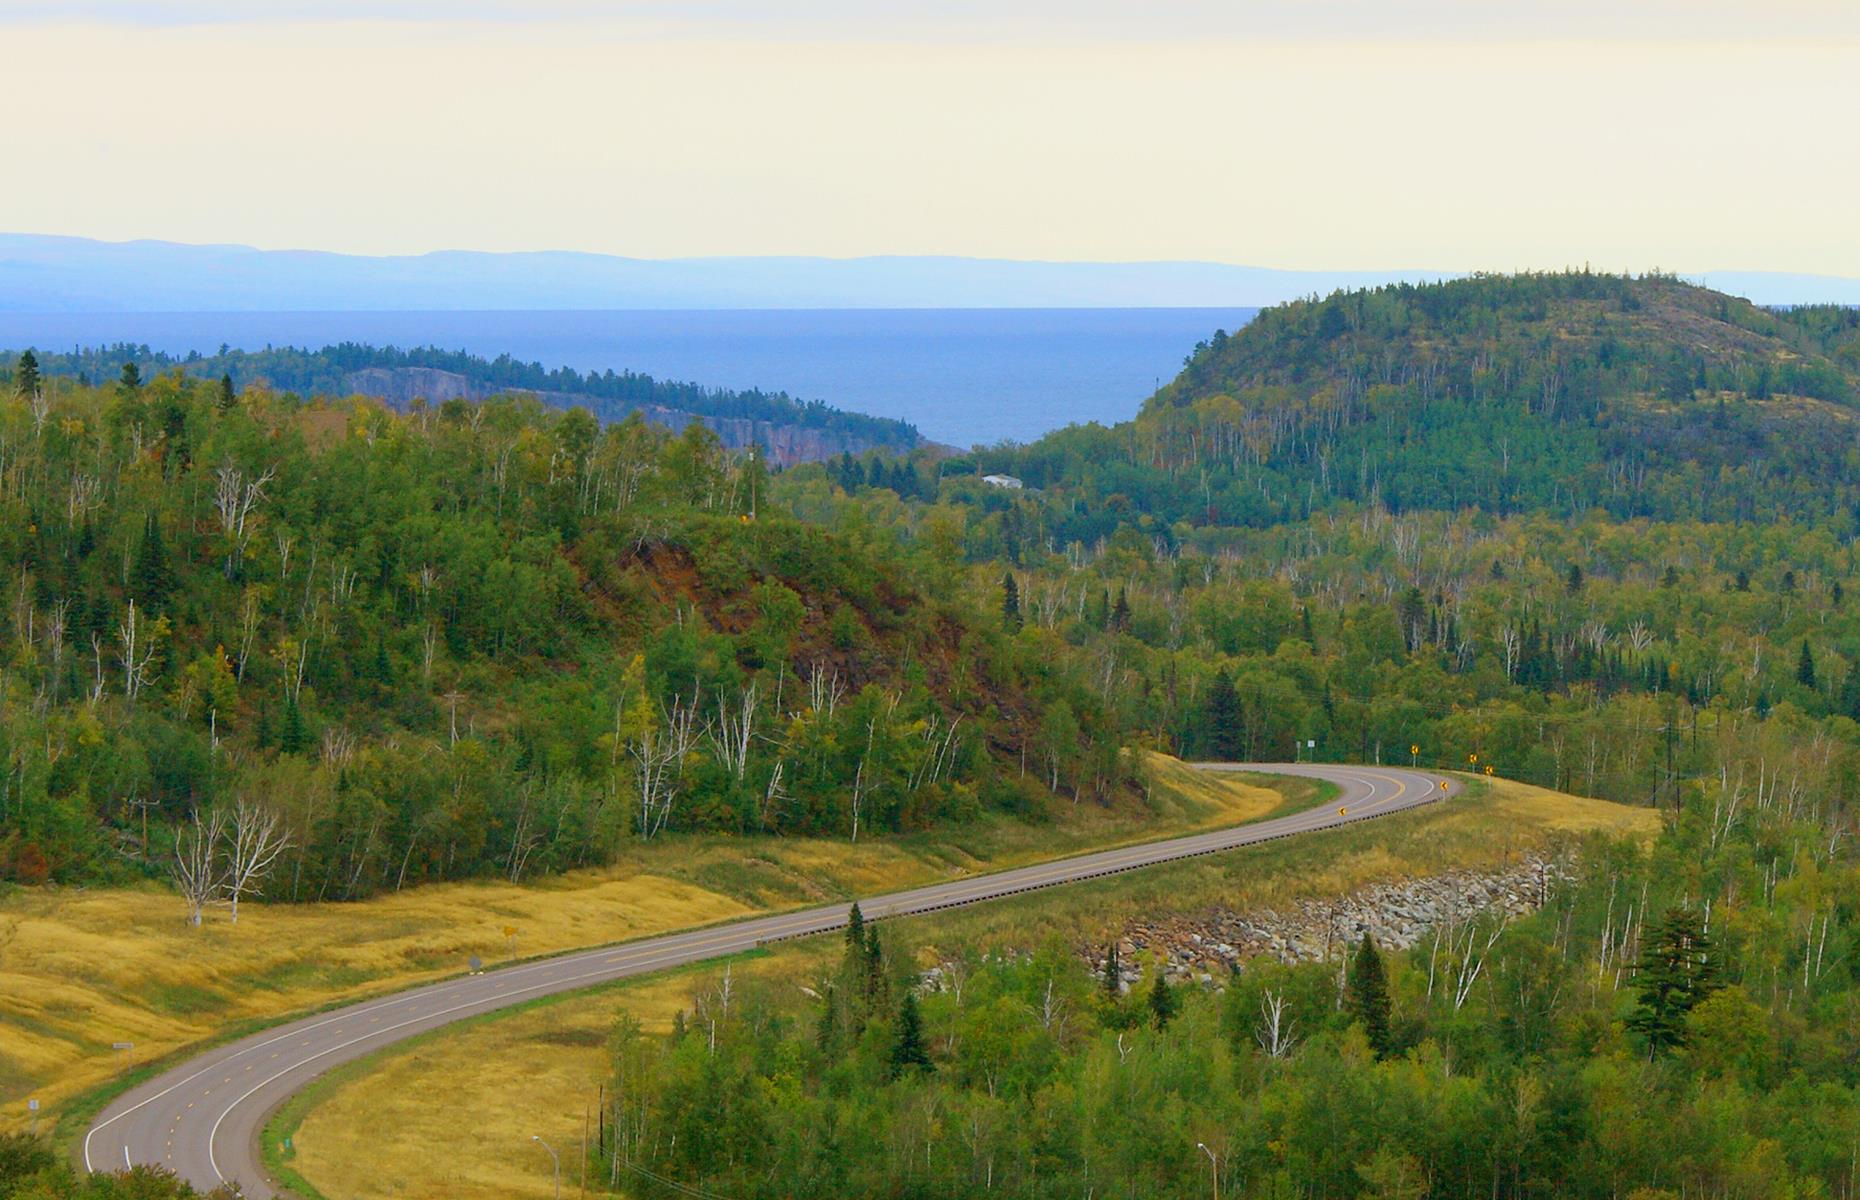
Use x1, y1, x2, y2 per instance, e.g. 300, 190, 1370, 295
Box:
0, 309, 1256, 447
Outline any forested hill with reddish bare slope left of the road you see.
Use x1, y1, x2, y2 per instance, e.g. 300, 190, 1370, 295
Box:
0, 365, 1127, 899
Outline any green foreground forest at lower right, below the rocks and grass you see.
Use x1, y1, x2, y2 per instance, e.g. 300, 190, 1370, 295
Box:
590, 777, 1860, 1200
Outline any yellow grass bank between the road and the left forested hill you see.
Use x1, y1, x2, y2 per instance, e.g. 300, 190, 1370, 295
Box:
0, 759, 1287, 1133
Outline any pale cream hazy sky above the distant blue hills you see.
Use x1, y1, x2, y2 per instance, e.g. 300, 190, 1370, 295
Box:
0, 0, 1860, 275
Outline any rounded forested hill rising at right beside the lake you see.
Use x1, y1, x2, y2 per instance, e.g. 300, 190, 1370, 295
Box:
982, 272, 1860, 538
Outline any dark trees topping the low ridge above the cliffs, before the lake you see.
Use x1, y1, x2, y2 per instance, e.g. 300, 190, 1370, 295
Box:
0, 342, 923, 448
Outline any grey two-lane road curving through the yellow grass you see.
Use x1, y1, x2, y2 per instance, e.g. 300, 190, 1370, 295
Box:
84, 763, 1445, 1196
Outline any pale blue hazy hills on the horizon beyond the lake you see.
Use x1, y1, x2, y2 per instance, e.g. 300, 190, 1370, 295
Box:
14, 234, 1860, 313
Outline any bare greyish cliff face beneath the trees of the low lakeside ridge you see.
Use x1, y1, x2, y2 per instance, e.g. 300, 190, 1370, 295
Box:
344, 367, 907, 467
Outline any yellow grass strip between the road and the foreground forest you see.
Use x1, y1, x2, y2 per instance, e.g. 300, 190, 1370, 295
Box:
279, 766, 1659, 1200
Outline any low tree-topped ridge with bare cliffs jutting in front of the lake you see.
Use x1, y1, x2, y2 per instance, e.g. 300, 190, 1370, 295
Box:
0, 342, 924, 467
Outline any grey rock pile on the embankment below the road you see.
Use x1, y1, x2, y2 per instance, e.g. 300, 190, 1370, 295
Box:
1084, 858, 1564, 990
